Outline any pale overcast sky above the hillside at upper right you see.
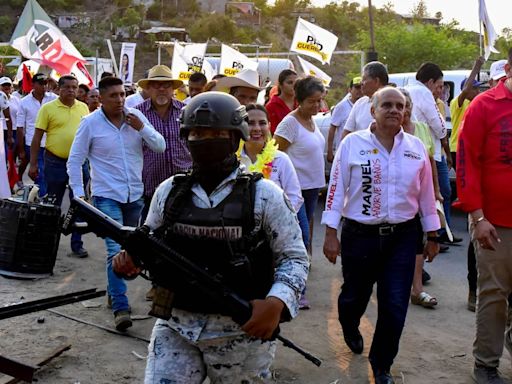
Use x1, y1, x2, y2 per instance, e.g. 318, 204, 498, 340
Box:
311, 0, 512, 34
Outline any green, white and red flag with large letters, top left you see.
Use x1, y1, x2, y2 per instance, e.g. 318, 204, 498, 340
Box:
10, 0, 85, 73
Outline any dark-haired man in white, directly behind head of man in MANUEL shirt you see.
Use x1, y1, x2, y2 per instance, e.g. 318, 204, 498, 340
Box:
341, 61, 389, 140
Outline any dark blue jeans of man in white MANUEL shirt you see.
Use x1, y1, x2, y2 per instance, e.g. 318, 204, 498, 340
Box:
338, 221, 418, 370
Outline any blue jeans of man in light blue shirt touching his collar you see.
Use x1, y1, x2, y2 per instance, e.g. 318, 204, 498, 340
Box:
93, 196, 144, 313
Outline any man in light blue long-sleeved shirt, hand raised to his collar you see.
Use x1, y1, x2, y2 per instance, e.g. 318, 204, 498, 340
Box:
67, 77, 165, 331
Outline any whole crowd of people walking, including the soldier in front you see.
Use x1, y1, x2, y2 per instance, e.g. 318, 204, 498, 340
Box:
0, 50, 512, 384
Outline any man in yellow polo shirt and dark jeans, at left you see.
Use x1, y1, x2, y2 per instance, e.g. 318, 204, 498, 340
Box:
28, 75, 89, 258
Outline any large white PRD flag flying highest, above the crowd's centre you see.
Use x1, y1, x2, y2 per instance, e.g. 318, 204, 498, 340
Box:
290, 17, 338, 64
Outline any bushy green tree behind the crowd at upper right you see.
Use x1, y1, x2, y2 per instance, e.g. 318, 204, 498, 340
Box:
354, 23, 478, 73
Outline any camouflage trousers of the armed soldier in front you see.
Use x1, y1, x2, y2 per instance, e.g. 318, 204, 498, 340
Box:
144, 320, 276, 384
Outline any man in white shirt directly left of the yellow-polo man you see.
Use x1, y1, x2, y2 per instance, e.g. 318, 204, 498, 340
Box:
16, 73, 58, 196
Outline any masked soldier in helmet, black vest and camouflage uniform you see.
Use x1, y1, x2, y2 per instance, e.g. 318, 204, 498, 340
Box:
114, 92, 309, 384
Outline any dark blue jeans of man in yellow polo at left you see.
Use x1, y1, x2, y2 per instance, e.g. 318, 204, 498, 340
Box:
44, 152, 89, 252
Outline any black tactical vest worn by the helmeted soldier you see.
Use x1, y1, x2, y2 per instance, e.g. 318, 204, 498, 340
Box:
156, 174, 274, 314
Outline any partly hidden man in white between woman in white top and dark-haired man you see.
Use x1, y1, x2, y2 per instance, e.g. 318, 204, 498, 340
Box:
327, 76, 363, 163
